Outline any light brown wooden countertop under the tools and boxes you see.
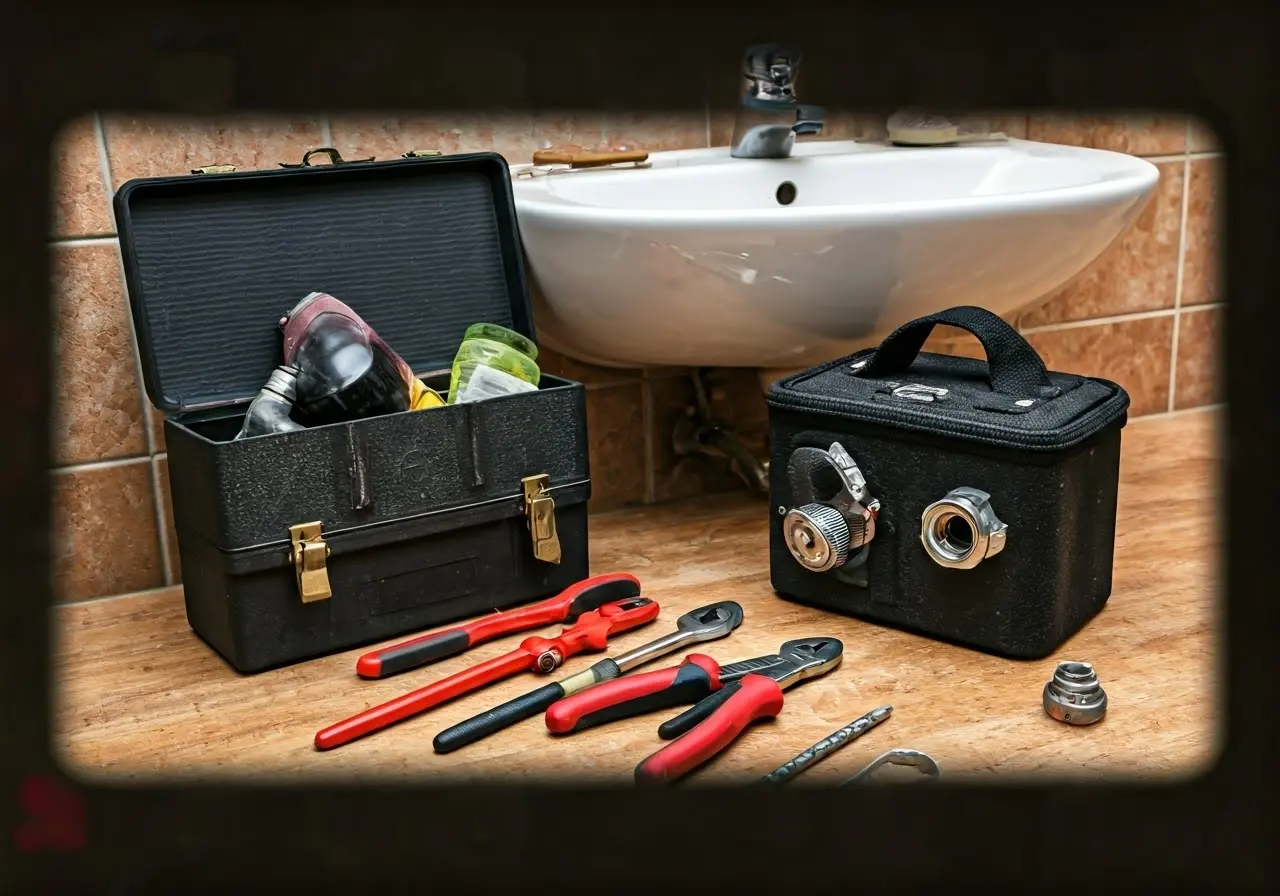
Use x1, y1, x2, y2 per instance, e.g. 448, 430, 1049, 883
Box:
55, 411, 1221, 783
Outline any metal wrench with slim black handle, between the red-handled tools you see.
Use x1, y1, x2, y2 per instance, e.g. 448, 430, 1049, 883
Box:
434, 600, 742, 753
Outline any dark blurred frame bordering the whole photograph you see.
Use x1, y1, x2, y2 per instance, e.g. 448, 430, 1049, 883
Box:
0, 0, 1280, 893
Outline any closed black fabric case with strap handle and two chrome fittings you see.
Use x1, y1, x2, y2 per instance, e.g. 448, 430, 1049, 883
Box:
768, 307, 1129, 658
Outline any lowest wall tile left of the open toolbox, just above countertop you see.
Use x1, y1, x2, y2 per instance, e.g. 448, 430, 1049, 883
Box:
52, 461, 164, 600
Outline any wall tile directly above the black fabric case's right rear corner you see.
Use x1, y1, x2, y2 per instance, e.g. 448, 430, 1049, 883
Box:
1027, 315, 1174, 417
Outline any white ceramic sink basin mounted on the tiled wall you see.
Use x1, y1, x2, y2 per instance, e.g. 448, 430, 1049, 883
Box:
512, 140, 1158, 370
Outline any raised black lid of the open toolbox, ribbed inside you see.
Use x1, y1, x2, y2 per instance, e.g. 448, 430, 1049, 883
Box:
114, 150, 536, 412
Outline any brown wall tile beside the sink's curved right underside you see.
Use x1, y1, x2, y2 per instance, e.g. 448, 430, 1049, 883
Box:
1023, 161, 1185, 326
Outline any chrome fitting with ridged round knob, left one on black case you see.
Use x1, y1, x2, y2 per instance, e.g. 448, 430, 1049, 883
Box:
778, 442, 879, 572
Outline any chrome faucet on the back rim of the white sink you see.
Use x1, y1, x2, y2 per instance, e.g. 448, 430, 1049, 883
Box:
730, 44, 824, 159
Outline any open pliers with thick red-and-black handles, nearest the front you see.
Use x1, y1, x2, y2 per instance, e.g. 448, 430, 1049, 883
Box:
547, 637, 845, 783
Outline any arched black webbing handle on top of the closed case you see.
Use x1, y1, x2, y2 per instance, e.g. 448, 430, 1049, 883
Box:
855, 305, 1059, 398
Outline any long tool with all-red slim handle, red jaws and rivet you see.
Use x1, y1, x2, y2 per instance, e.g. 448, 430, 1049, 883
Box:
315, 598, 658, 750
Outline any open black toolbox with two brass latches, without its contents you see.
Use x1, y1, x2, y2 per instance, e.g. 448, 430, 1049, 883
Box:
115, 151, 590, 672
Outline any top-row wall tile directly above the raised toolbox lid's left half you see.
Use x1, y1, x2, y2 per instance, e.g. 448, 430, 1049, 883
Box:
102, 115, 321, 188
